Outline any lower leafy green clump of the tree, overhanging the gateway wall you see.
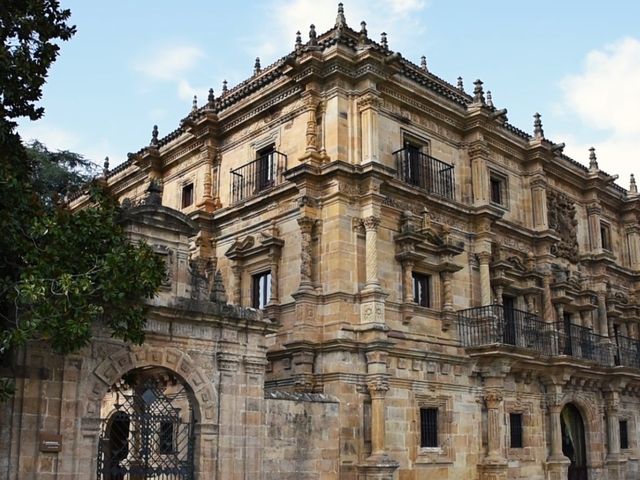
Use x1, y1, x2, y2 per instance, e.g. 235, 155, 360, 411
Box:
2, 186, 164, 353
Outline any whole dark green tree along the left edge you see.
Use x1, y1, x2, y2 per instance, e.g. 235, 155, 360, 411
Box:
0, 0, 164, 400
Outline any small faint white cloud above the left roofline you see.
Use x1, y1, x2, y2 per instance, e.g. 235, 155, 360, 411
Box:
134, 45, 204, 81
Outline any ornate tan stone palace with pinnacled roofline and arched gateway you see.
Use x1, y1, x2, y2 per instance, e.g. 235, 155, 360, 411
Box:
0, 6, 640, 480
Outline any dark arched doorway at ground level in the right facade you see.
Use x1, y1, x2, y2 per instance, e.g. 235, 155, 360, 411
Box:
560, 403, 589, 480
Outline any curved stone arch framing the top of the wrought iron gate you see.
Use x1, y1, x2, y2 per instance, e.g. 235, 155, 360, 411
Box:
85, 345, 216, 423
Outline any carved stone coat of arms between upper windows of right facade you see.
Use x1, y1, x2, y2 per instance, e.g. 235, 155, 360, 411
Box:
547, 190, 578, 262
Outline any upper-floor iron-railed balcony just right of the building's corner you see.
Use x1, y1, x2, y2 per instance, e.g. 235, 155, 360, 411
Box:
393, 147, 454, 200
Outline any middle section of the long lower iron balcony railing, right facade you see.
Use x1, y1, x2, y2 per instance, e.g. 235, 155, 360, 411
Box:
556, 322, 613, 366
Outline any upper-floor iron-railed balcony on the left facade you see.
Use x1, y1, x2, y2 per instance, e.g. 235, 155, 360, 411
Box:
231, 150, 287, 203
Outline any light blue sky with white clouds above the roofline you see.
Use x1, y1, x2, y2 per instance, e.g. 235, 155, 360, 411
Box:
19, 0, 640, 188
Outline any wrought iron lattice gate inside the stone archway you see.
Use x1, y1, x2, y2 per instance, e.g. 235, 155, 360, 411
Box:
98, 379, 194, 480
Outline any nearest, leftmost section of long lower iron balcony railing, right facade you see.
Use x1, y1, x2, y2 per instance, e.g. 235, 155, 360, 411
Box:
458, 304, 554, 354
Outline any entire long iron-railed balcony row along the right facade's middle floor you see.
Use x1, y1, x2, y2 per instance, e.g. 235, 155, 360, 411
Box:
458, 305, 616, 368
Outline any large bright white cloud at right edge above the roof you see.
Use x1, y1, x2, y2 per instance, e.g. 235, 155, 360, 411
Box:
560, 38, 640, 188
